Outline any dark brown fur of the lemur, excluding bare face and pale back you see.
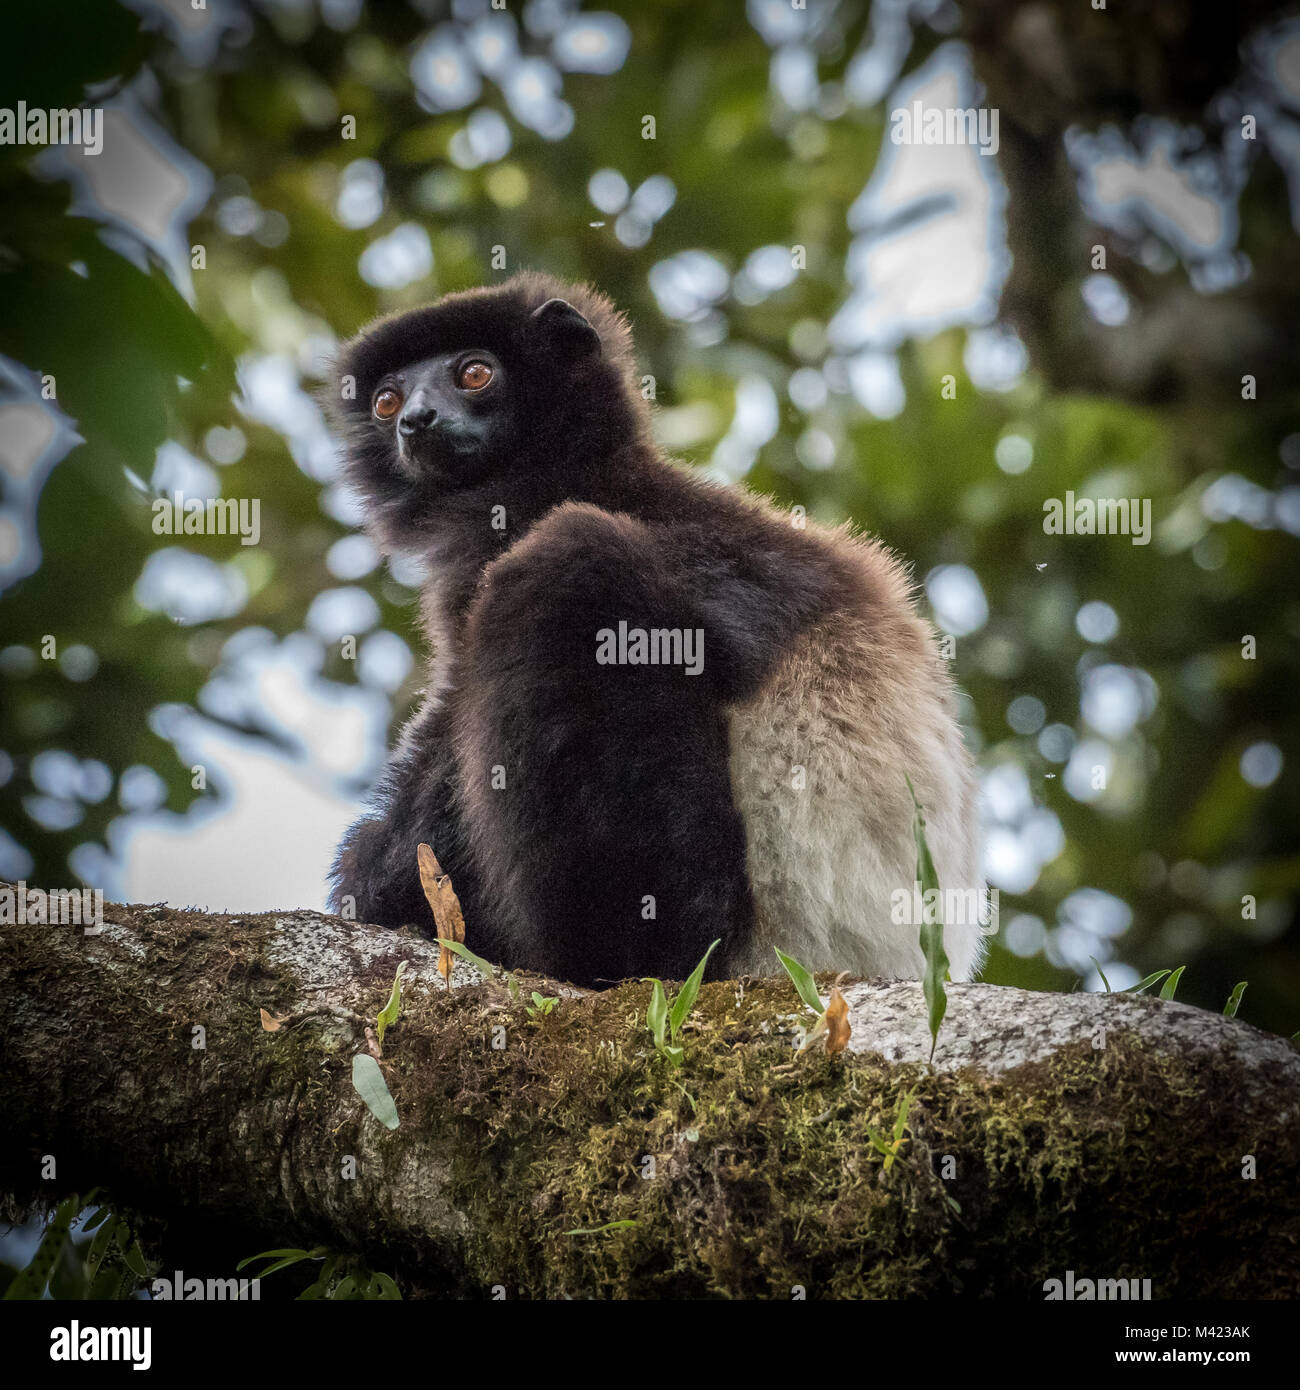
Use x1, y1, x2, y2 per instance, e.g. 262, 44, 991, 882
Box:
325, 275, 870, 983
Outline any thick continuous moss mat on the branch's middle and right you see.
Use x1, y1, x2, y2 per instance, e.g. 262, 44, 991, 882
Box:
402, 981, 1300, 1298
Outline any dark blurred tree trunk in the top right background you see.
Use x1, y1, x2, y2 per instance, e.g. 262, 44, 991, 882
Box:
961, 0, 1300, 407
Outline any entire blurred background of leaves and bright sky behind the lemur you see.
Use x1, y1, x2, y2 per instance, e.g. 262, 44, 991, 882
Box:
0, 0, 1300, 1033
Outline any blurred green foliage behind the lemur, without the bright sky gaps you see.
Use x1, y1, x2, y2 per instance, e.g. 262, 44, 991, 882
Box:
0, 0, 1300, 1033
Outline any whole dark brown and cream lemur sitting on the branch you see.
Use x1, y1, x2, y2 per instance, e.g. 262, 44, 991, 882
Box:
331, 272, 984, 984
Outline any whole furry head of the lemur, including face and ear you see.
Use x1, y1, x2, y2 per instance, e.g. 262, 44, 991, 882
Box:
330, 287, 625, 549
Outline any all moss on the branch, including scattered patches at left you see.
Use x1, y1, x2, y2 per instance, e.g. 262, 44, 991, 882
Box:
22, 909, 1300, 1298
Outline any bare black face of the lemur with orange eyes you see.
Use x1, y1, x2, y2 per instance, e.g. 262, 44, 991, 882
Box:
370, 348, 520, 487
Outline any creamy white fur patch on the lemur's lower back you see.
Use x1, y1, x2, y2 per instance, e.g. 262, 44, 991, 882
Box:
729, 614, 984, 980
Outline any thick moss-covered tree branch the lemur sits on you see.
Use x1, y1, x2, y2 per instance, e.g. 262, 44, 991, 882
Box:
0, 905, 1300, 1298
